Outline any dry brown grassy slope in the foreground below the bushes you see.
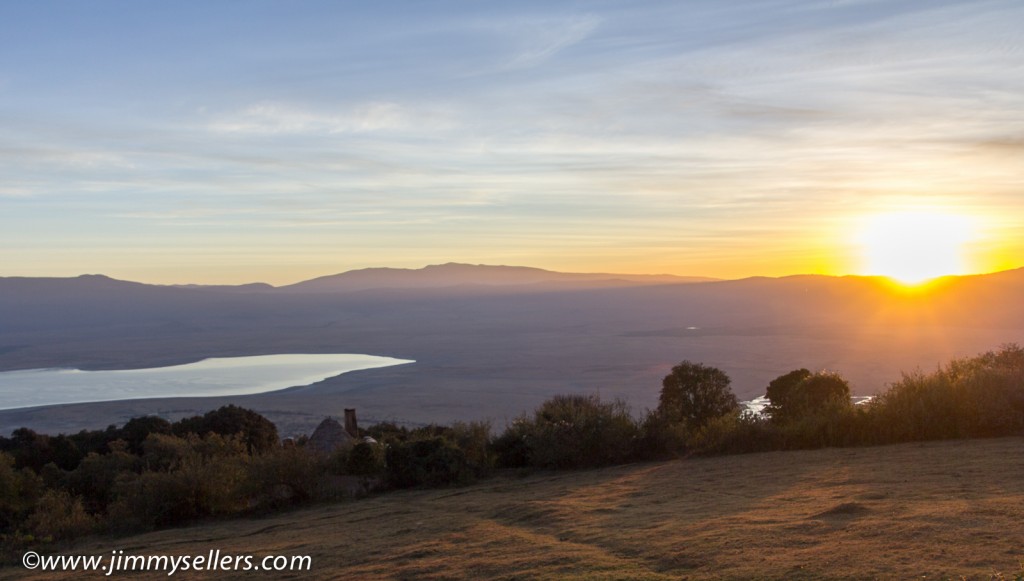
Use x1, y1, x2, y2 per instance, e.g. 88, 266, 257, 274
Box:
14, 438, 1024, 579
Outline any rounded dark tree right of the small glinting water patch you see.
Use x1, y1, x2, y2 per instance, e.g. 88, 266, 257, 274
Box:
768, 369, 850, 423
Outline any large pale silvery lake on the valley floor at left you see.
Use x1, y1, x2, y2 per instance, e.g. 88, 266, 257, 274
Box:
0, 354, 414, 410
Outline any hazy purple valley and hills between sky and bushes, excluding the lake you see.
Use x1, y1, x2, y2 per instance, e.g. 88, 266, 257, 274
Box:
0, 263, 1024, 434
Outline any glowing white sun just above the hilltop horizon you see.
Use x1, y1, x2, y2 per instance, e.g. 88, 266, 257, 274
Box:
860, 211, 973, 285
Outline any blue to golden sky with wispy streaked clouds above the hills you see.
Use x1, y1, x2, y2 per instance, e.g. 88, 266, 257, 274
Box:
0, 0, 1024, 284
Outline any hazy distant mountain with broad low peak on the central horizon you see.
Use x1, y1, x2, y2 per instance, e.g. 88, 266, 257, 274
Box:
280, 262, 716, 293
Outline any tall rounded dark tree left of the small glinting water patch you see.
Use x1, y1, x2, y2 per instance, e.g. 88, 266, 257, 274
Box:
657, 361, 739, 429
